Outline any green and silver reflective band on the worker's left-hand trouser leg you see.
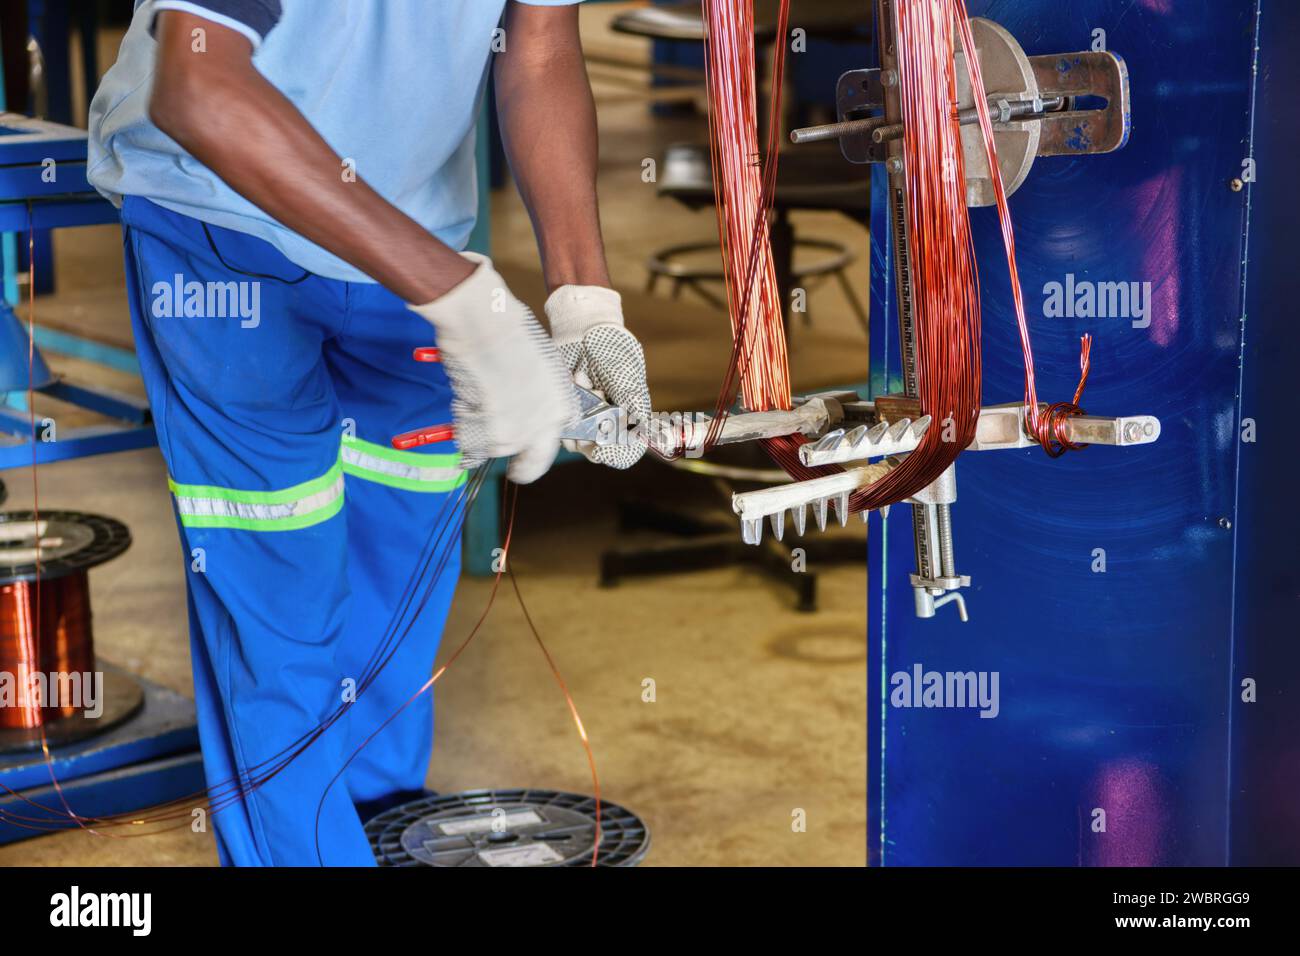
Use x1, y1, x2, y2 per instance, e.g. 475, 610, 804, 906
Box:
168, 463, 343, 531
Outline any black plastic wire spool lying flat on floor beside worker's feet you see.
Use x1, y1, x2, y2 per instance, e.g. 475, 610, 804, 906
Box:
365, 790, 650, 866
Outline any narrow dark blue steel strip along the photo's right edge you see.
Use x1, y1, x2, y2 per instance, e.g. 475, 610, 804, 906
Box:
1230, 0, 1300, 866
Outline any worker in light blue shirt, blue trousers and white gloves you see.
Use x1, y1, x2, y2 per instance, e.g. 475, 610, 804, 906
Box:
88, 0, 650, 866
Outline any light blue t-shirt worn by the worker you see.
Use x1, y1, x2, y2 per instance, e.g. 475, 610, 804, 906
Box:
88, 0, 579, 281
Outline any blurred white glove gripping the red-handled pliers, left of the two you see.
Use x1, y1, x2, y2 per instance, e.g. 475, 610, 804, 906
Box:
410, 252, 577, 484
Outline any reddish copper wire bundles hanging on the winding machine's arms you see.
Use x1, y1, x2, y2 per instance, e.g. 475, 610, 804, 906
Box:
703, 0, 1091, 494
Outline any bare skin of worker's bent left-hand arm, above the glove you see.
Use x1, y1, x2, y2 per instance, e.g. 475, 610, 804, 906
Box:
150, 10, 475, 302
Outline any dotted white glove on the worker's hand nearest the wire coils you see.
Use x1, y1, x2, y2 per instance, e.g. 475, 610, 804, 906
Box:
546, 285, 651, 468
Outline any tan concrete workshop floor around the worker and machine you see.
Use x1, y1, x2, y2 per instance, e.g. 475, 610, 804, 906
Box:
0, 4, 866, 865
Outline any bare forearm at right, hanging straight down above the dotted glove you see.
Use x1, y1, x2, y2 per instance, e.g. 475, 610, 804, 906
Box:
495, 0, 610, 289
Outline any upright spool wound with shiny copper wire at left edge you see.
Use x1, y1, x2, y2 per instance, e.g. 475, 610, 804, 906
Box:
0, 511, 144, 753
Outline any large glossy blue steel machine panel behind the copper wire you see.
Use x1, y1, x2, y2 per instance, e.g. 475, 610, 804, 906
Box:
868, 0, 1284, 865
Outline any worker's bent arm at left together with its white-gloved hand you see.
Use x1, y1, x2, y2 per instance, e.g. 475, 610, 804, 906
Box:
150, 10, 576, 483
